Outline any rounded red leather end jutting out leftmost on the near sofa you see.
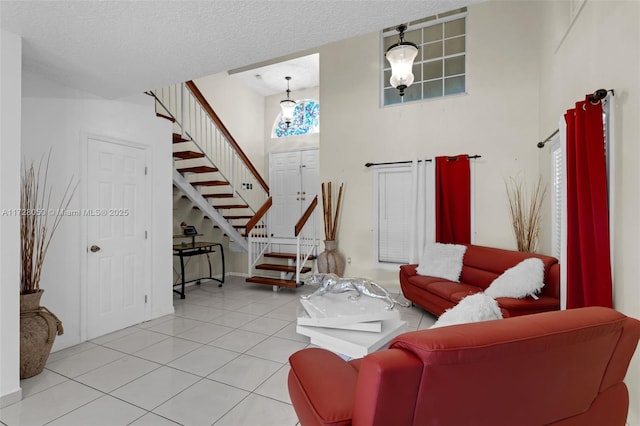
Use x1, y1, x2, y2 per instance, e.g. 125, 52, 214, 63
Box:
288, 348, 358, 425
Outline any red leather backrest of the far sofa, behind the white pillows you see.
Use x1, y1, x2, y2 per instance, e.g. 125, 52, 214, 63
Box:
460, 244, 560, 298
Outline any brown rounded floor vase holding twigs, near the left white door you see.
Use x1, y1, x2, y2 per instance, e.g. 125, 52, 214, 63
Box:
20, 290, 63, 379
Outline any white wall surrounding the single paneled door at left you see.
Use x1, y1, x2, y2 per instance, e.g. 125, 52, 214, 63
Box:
21, 72, 173, 351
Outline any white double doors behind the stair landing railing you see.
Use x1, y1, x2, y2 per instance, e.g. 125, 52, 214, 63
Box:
269, 149, 320, 238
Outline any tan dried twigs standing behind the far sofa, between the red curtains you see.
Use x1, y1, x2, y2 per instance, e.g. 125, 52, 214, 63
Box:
505, 176, 547, 253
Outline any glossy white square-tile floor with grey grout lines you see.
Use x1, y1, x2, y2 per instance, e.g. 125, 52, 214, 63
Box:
0, 277, 435, 426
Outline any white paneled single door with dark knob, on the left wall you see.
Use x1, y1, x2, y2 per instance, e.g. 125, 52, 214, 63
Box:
85, 137, 150, 339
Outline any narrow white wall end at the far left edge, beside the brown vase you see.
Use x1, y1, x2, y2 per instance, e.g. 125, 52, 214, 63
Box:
0, 30, 22, 408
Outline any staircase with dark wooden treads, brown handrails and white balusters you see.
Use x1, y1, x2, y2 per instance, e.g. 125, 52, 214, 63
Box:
149, 81, 318, 290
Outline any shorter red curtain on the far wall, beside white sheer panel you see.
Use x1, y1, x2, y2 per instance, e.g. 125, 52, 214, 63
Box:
436, 154, 471, 244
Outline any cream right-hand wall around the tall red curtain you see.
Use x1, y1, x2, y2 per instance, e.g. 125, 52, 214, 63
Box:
538, 1, 640, 425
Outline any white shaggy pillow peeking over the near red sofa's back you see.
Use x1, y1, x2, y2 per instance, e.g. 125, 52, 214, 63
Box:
430, 293, 502, 328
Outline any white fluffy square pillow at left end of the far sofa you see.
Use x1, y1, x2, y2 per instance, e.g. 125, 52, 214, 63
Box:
416, 243, 467, 282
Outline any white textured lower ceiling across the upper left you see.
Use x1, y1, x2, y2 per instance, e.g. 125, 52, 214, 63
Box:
0, 0, 478, 98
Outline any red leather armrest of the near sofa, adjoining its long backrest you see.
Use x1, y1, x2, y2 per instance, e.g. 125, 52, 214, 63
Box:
353, 349, 423, 426
